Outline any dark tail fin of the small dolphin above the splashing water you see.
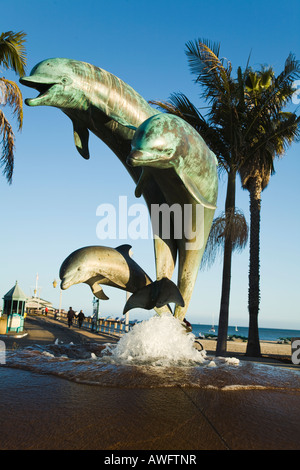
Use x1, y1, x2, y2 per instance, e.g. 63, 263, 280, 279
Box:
123, 277, 184, 315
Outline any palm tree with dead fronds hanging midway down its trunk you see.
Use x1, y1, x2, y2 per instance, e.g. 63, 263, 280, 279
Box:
152, 40, 248, 355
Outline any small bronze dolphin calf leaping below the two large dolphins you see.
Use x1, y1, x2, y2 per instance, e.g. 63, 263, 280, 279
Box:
59, 245, 182, 313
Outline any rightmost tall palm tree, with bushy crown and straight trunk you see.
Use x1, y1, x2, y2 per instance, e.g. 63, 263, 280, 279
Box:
239, 54, 300, 357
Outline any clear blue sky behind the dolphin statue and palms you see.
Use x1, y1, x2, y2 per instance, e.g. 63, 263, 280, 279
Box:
0, 0, 300, 329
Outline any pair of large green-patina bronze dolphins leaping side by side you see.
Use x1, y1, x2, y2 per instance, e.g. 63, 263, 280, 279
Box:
20, 58, 217, 319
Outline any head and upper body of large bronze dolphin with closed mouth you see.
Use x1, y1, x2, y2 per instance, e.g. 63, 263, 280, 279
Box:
127, 114, 218, 210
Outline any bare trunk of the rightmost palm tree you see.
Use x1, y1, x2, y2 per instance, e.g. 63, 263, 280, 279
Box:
246, 177, 261, 357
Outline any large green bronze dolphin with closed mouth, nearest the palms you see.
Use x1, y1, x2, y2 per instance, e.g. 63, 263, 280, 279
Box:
127, 114, 218, 320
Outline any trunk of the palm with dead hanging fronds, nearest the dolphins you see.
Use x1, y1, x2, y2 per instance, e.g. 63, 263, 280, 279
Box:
216, 170, 236, 356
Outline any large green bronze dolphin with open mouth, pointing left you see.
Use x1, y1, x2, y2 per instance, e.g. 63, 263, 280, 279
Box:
20, 58, 177, 316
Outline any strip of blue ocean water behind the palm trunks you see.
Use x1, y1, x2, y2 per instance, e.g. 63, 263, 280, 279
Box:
192, 324, 300, 341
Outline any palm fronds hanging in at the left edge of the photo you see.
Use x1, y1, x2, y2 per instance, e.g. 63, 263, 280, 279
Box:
0, 31, 26, 183
